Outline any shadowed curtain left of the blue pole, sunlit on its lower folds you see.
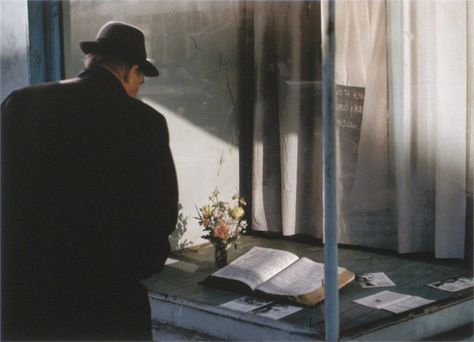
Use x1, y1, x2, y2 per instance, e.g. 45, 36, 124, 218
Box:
252, 1, 322, 237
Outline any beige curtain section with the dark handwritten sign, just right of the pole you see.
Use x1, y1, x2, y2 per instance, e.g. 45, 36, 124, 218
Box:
334, 0, 396, 249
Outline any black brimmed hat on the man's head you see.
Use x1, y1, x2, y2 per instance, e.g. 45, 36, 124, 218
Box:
80, 21, 159, 77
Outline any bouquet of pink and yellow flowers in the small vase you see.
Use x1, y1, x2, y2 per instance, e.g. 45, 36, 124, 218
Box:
196, 188, 247, 247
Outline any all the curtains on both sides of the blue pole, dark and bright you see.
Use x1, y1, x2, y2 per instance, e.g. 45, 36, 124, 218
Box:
252, 0, 473, 258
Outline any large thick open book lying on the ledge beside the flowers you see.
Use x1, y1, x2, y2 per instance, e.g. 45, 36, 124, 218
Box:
203, 247, 355, 305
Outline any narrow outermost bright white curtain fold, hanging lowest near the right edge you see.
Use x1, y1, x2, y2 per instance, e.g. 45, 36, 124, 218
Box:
430, 1, 468, 258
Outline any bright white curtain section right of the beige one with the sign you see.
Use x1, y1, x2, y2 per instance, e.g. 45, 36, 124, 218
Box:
389, 0, 473, 258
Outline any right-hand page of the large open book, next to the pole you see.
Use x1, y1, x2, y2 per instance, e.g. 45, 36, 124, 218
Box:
258, 257, 324, 296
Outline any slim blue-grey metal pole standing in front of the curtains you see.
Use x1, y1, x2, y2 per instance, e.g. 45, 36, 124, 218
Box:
323, 0, 339, 341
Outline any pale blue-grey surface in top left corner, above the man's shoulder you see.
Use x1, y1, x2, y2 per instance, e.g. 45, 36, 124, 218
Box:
0, 0, 29, 101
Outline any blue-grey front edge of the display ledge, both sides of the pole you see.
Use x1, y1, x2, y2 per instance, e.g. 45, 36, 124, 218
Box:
149, 293, 474, 341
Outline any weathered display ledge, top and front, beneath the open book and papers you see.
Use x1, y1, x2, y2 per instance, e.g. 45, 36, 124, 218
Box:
143, 236, 474, 341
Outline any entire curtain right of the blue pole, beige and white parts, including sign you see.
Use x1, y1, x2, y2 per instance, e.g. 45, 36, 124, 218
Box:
328, 0, 472, 258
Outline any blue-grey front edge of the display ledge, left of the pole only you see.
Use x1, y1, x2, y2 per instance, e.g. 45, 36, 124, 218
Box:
148, 293, 323, 341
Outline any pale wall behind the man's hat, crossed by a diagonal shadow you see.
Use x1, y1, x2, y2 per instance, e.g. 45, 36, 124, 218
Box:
64, 0, 241, 249
